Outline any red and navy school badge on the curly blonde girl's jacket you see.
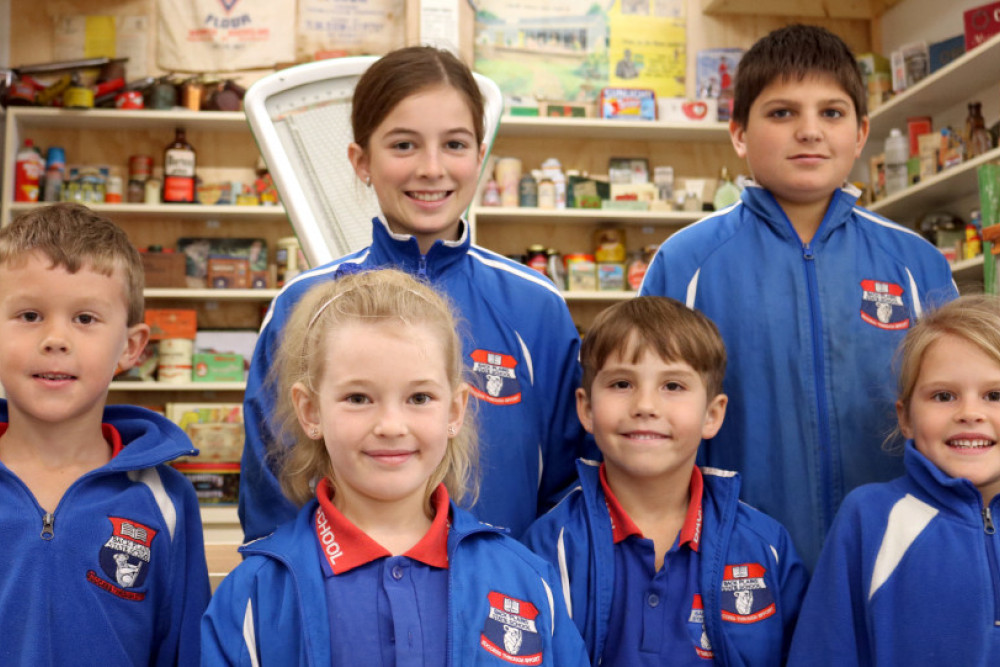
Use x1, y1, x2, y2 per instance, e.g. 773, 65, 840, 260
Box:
479, 591, 542, 665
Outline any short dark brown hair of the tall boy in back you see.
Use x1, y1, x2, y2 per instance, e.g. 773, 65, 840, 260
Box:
733, 23, 868, 128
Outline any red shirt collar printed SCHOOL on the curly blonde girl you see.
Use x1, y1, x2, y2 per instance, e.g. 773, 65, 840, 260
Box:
313, 479, 451, 574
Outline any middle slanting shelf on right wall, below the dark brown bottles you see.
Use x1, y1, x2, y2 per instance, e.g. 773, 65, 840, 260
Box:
869, 144, 1000, 224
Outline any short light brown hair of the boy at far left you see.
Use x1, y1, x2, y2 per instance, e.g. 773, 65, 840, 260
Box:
0, 203, 146, 327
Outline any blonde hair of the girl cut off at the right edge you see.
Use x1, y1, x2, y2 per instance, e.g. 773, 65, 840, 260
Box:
890, 294, 1000, 438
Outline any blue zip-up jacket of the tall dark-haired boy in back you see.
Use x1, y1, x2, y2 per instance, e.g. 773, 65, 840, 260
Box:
640, 185, 958, 568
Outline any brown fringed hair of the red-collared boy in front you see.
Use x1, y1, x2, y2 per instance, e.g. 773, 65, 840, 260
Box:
580, 296, 726, 399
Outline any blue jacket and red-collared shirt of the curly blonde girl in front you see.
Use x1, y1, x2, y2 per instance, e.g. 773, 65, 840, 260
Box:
202, 484, 587, 667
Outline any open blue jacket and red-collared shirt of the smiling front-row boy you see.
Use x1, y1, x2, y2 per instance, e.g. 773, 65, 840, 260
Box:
524, 460, 807, 665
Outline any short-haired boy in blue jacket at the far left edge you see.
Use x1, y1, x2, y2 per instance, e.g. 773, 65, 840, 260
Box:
0, 204, 210, 665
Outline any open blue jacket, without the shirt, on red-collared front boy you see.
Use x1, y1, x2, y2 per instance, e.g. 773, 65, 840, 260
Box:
524, 460, 807, 666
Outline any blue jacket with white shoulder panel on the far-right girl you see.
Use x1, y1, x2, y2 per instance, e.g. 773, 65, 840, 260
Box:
788, 441, 1000, 667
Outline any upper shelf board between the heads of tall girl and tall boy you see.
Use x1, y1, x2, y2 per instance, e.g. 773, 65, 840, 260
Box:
500, 116, 729, 142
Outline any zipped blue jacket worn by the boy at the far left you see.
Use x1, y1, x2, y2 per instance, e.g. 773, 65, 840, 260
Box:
0, 401, 210, 665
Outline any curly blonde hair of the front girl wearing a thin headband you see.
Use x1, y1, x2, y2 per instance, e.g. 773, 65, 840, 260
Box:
268, 269, 479, 509
